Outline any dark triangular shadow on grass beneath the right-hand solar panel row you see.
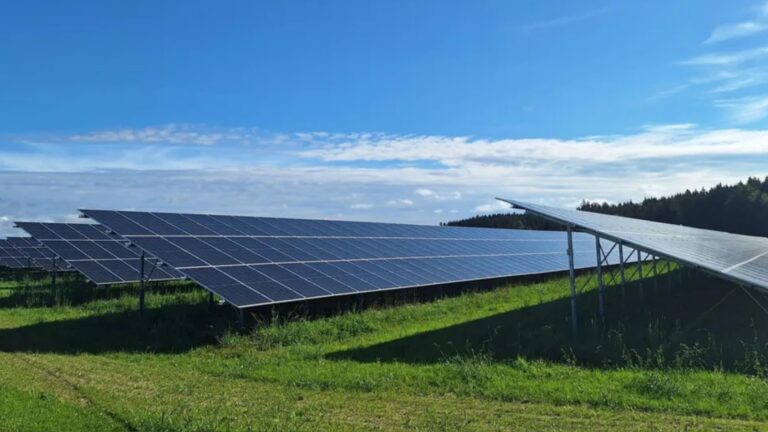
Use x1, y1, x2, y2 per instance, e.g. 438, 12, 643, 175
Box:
329, 270, 768, 374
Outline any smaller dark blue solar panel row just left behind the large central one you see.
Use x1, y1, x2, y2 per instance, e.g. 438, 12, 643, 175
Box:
16, 222, 183, 285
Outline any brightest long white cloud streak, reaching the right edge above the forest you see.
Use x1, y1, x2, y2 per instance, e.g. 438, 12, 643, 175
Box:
299, 124, 768, 166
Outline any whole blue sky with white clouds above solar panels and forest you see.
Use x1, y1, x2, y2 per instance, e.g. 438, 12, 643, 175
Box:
0, 0, 768, 236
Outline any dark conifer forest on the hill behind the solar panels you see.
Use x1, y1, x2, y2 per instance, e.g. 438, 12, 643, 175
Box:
444, 177, 768, 237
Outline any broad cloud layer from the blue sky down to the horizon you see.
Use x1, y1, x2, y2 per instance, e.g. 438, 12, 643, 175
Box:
0, 124, 768, 235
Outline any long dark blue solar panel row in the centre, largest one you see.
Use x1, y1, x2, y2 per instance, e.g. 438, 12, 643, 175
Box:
81, 210, 615, 307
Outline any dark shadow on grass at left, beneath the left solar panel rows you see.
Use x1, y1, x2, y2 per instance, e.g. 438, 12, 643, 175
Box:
0, 303, 232, 354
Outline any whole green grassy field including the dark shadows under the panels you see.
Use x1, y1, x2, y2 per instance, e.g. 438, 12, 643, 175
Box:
0, 264, 768, 431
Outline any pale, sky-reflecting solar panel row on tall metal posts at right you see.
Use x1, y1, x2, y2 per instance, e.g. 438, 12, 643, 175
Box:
501, 199, 768, 291
